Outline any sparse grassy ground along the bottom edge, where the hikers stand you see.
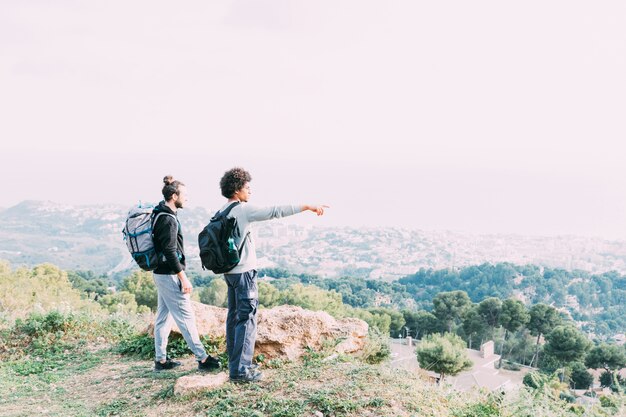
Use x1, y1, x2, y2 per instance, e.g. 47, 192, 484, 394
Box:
0, 340, 617, 417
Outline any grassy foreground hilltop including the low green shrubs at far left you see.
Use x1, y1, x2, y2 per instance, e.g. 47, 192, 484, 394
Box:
0, 315, 624, 417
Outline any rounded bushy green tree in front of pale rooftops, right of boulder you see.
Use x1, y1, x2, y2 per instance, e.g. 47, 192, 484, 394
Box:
416, 333, 473, 381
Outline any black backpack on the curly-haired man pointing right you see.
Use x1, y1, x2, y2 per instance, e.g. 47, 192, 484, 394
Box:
198, 201, 250, 274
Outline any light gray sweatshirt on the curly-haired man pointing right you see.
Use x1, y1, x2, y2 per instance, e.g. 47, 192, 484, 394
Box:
220, 202, 302, 274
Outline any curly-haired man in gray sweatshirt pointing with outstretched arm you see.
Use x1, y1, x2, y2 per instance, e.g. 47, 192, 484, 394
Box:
220, 168, 328, 382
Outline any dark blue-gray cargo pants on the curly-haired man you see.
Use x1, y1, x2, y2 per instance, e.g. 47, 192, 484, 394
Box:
224, 269, 259, 377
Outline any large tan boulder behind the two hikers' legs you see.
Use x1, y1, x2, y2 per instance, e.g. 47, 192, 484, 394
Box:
147, 301, 368, 360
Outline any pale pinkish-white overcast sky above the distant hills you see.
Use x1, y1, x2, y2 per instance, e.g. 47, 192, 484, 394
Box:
0, 0, 626, 239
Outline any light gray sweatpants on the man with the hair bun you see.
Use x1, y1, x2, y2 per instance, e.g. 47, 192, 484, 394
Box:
154, 274, 208, 361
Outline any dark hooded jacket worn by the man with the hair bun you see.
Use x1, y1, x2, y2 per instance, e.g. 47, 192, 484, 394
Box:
152, 201, 185, 275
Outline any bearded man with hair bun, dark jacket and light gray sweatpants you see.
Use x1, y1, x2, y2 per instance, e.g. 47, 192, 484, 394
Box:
153, 176, 220, 371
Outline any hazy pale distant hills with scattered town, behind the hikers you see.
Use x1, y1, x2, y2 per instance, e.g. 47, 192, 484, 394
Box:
0, 201, 626, 280
